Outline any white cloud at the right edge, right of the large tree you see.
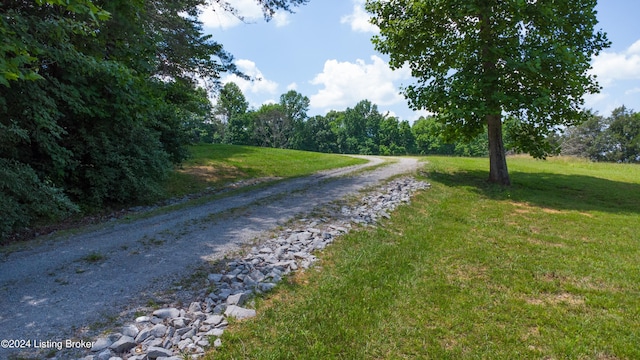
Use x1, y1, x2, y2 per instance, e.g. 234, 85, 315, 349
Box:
590, 40, 640, 87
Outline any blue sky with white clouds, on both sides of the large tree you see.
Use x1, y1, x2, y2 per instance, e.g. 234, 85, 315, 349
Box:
201, 0, 640, 121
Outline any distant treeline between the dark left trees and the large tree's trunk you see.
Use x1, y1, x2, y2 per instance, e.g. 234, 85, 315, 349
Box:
202, 83, 488, 156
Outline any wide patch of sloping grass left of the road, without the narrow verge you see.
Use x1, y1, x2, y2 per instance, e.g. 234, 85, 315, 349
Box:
165, 144, 366, 197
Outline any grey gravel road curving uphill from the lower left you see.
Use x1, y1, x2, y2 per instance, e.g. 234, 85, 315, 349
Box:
0, 157, 418, 359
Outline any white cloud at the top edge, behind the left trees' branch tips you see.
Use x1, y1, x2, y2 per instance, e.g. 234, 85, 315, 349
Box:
200, 0, 289, 29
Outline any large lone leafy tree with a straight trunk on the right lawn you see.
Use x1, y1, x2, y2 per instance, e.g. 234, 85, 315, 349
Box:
366, 0, 609, 185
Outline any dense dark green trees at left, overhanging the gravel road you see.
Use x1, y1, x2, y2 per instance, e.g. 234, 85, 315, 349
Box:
0, 0, 307, 238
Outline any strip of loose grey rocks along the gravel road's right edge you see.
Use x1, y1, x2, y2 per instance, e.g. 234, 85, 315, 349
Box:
82, 178, 430, 360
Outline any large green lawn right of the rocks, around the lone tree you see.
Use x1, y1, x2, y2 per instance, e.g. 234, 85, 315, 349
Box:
208, 157, 640, 359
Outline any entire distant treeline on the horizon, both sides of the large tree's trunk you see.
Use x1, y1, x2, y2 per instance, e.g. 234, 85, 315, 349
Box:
198, 82, 640, 163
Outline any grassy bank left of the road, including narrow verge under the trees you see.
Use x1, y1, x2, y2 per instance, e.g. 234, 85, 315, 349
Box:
0, 145, 366, 246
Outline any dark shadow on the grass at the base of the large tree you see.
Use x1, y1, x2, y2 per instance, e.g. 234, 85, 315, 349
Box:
429, 171, 640, 213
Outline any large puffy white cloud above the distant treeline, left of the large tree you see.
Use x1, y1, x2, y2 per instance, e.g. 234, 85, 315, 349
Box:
310, 55, 411, 109
